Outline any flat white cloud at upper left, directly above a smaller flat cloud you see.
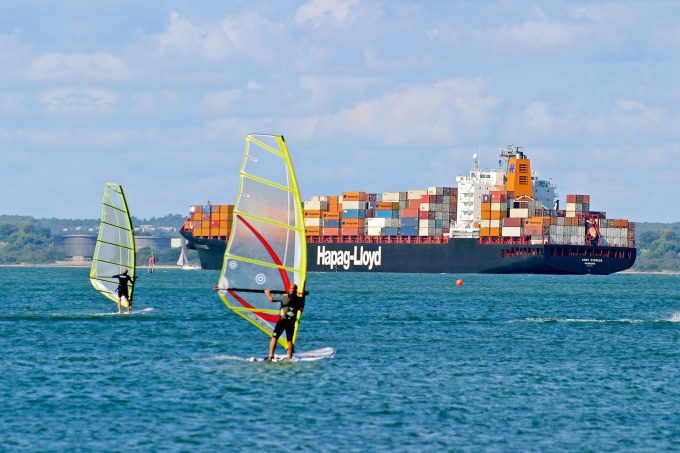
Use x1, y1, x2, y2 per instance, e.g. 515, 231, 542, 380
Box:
28, 52, 130, 80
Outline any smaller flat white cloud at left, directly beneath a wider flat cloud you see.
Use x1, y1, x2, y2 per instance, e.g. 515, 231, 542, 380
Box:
38, 88, 118, 115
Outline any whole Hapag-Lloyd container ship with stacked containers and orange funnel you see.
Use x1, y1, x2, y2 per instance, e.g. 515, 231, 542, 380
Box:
180, 146, 636, 275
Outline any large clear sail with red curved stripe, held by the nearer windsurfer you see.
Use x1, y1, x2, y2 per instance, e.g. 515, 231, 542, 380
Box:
218, 134, 307, 346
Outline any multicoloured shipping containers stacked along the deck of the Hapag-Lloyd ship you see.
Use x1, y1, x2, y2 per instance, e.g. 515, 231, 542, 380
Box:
183, 191, 635, 247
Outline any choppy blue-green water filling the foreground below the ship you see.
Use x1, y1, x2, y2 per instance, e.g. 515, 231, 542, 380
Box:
0, 268, 680, 452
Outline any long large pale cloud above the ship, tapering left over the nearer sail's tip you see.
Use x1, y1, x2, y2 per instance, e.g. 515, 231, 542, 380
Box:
206, 79, 498, 146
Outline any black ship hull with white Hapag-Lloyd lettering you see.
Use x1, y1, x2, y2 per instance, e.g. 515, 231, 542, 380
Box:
182, 231, 636, 275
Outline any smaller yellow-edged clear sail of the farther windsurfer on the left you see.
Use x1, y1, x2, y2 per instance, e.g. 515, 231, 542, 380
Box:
90, 183, 135, 308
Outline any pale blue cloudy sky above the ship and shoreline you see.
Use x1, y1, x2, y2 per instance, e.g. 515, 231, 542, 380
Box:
0, 0, 680, 222
